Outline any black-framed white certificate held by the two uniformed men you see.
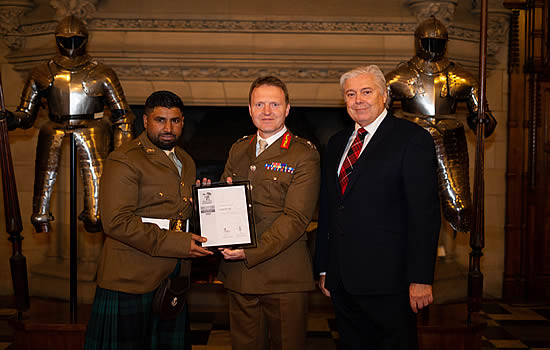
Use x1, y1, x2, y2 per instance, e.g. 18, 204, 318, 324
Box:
193, 181, 256, 248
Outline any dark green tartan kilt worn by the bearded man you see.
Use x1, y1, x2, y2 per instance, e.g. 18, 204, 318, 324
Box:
84, 264, 191, 350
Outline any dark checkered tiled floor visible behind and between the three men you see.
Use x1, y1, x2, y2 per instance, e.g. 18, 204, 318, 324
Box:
0, 302, 550, 350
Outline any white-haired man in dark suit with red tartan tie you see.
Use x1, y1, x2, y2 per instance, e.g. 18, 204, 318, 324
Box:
316, 65, 441, 349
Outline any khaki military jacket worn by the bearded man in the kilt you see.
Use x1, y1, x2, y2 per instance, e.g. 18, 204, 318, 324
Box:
97, 132, 196, 294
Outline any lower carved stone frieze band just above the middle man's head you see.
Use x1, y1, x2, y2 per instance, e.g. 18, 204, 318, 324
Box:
111, 65, 350, 82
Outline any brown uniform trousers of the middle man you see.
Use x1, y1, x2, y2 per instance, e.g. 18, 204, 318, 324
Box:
229, 291, 308, 350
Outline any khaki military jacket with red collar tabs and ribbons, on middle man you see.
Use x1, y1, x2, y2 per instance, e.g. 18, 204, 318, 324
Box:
219, 132, 320, 294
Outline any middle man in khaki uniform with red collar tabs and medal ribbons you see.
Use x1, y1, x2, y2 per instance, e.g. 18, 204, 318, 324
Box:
219, 77, 320, 350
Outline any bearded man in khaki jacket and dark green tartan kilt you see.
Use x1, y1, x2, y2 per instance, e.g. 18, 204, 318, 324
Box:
85, 91, 211, 349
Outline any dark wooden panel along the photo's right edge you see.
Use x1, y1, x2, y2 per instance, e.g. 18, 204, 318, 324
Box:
503, 1, 550, 302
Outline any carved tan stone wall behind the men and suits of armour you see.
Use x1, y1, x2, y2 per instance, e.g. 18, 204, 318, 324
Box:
0, 0, 507, 297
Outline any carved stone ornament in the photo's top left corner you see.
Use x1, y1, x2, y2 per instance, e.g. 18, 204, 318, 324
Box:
0, 0, 33, 50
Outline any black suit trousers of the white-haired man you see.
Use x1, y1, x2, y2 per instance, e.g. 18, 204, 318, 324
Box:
331, 283, 418, 350
